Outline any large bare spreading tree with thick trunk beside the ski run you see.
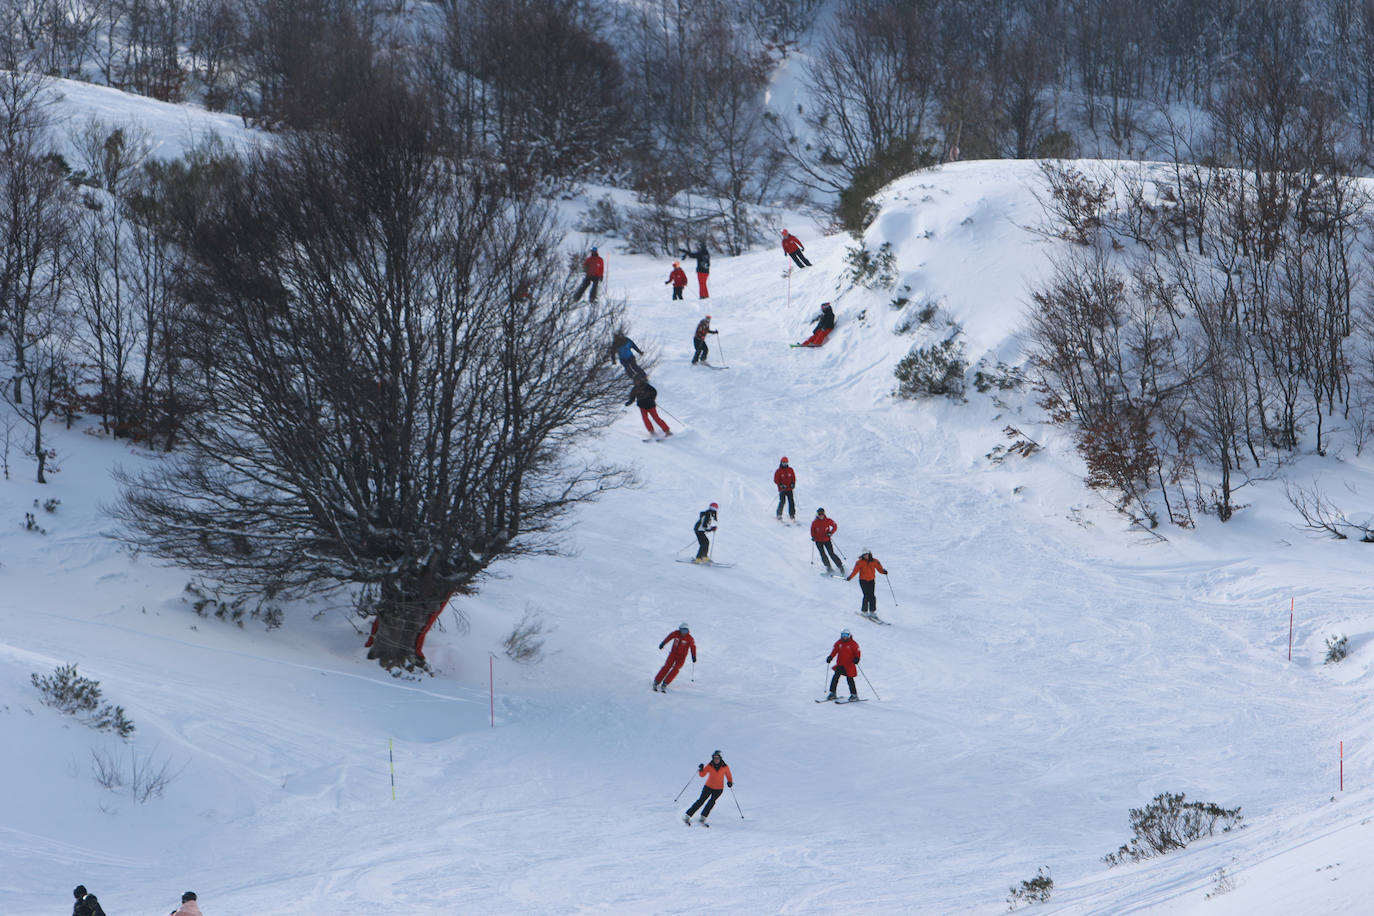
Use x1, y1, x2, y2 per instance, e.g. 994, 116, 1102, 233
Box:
117, 70, 631, 667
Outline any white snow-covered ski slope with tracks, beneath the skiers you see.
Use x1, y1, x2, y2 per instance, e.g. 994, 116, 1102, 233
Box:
0, 82, 1374, 916
